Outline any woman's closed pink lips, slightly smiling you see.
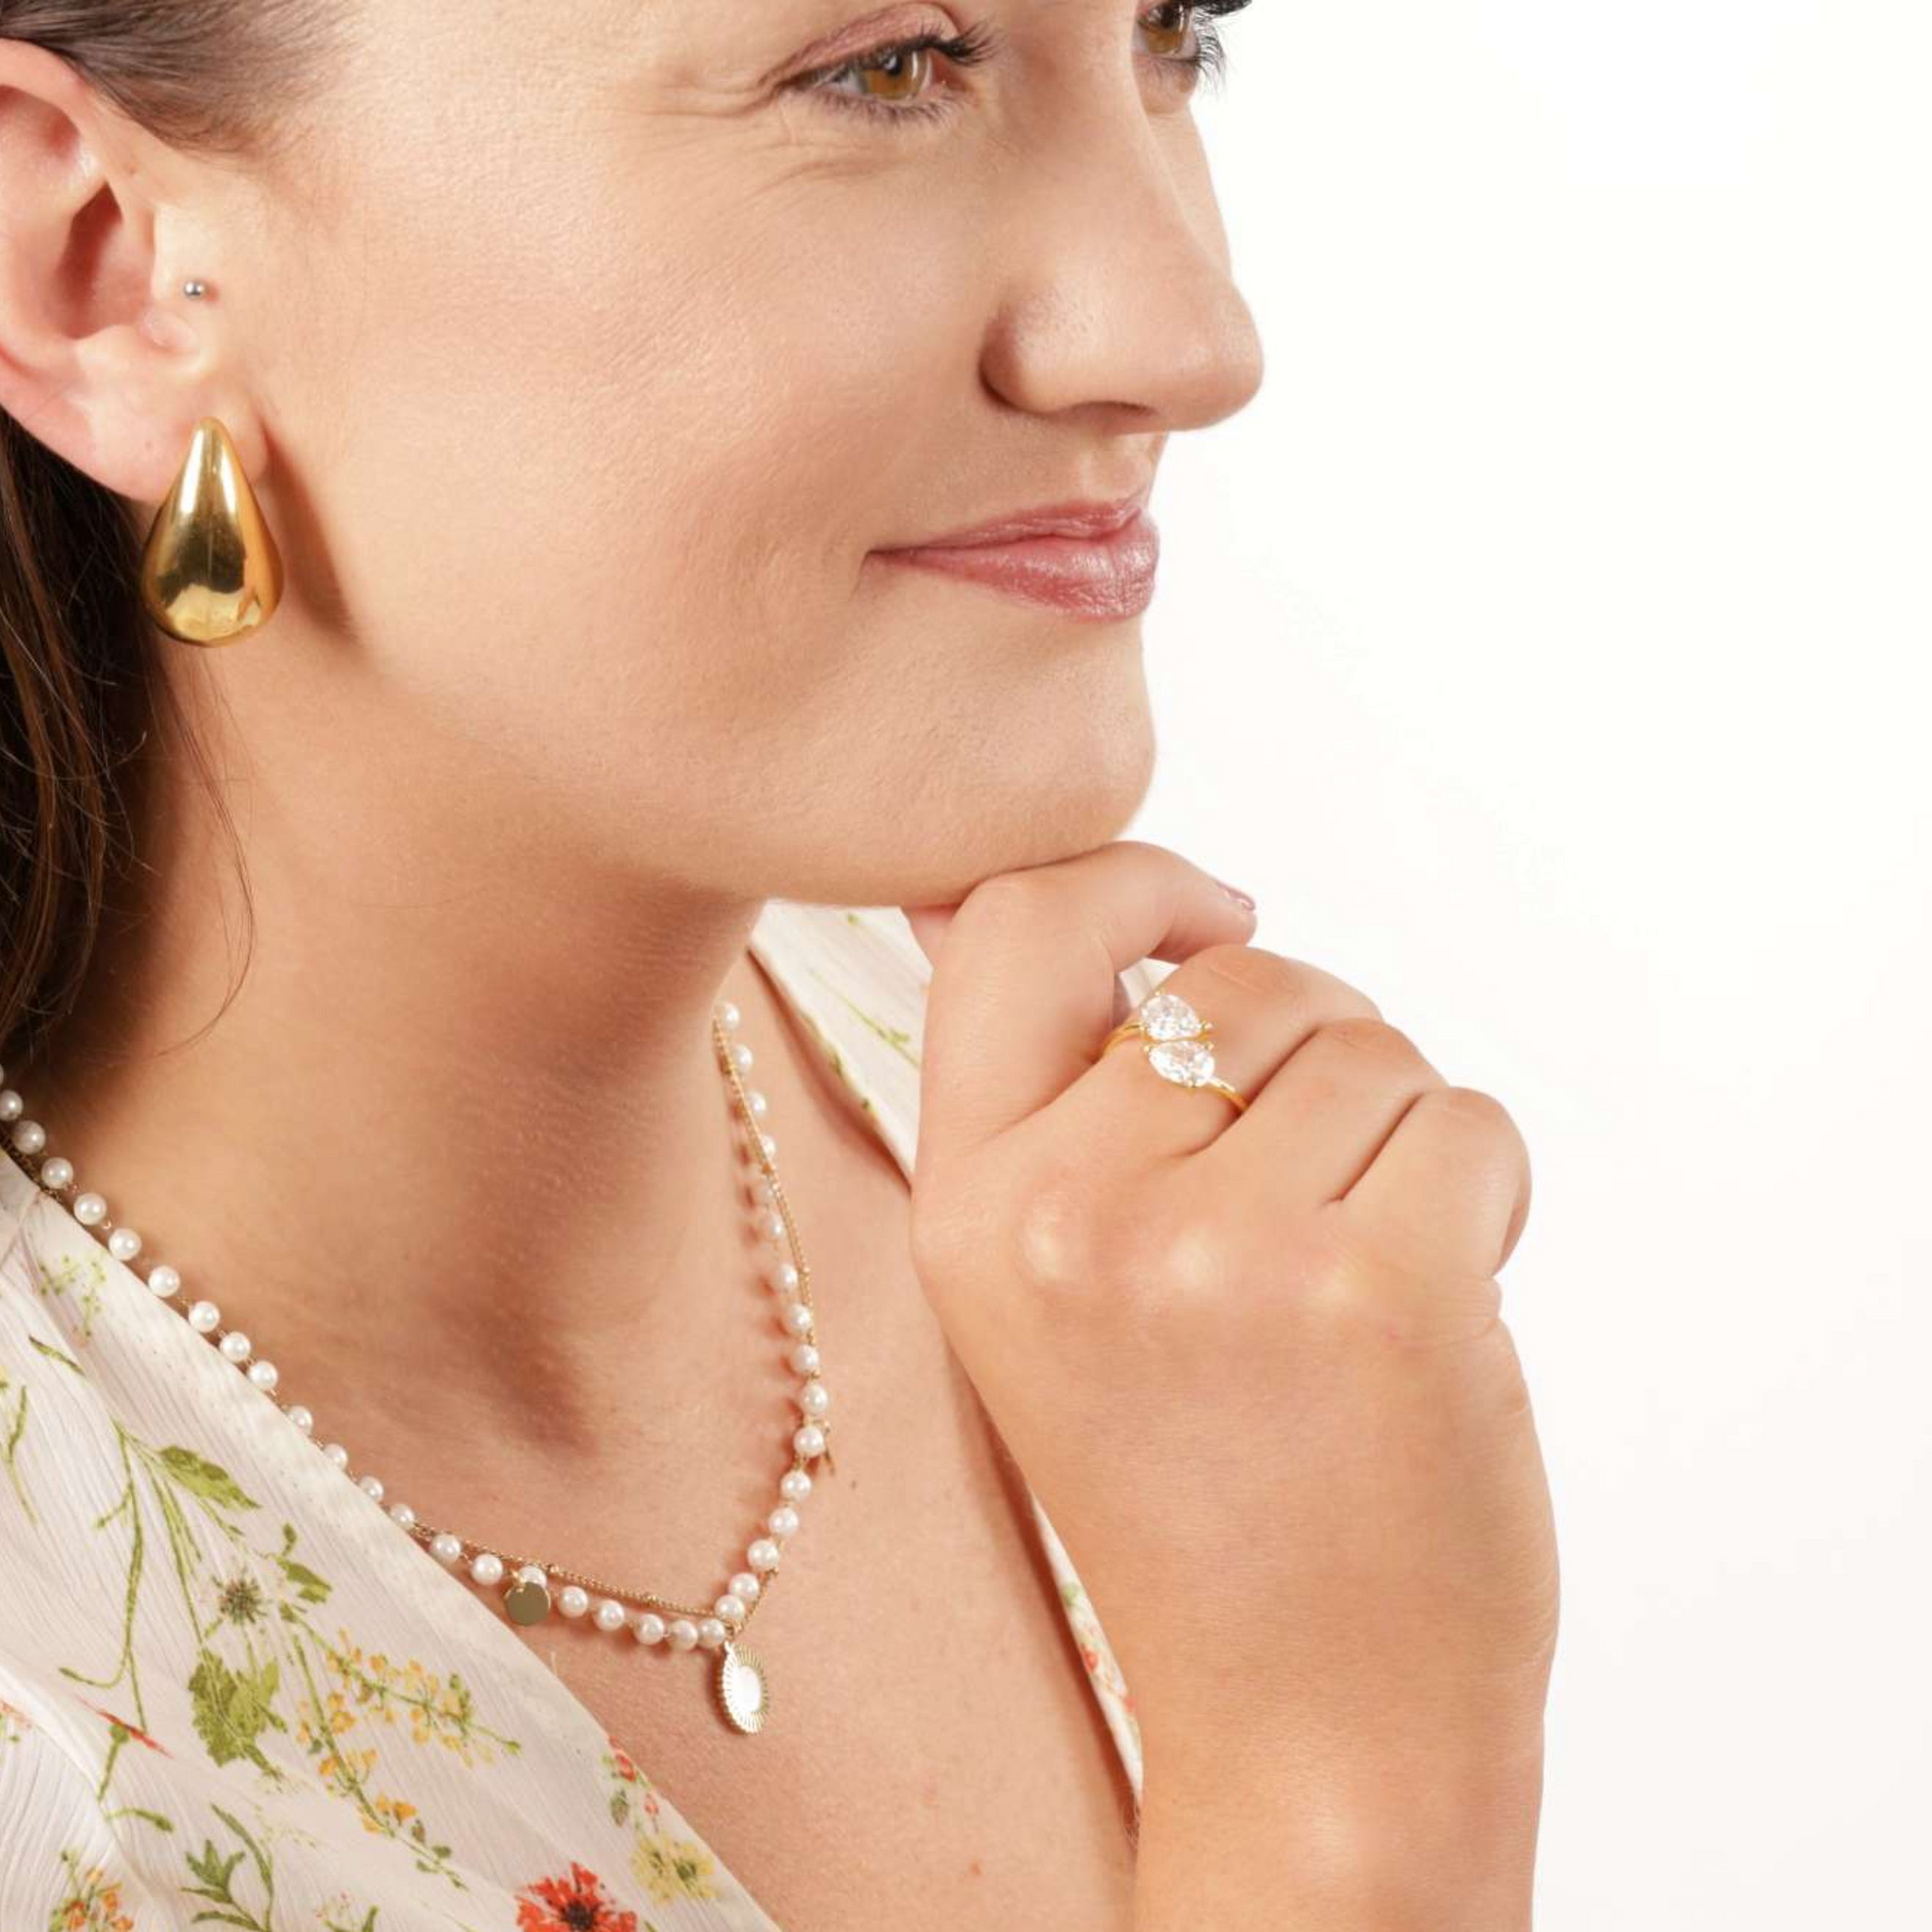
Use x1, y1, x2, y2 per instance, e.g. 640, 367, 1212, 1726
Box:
877, 490, 1162, 621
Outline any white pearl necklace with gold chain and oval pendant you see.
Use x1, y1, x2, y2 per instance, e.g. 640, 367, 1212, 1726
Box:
0, 999, 837, 1733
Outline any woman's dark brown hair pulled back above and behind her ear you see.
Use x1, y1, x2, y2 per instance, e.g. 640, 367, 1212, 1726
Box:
0, 0, 345, 1053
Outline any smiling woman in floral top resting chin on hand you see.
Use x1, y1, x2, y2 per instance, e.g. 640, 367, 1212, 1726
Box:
0, 0, 1556, 1932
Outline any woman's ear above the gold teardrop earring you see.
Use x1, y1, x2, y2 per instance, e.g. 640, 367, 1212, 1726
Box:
0, 39, 267, 504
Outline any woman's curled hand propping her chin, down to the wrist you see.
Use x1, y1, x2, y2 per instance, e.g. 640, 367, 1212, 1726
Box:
908, 841, 1557, 1830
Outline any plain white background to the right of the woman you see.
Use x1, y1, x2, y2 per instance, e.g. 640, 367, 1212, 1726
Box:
1130, 0, 1932, 1932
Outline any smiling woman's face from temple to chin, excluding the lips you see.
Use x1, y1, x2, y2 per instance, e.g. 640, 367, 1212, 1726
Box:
157, 0, 1262, 904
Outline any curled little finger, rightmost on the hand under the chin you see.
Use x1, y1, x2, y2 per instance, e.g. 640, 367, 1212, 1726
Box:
1339, 1086, 1530, 1275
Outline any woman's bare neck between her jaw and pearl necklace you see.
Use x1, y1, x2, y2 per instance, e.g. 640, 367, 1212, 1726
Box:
6, 718, 842, 1470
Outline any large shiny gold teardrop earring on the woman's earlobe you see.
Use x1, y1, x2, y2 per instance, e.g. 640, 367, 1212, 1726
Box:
141, 282, 282, 645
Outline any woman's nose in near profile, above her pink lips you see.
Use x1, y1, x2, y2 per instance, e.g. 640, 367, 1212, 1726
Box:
982, 79, 1262, 431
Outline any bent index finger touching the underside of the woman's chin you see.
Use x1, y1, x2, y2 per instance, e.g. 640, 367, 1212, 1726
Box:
915, 839, 1254, 1160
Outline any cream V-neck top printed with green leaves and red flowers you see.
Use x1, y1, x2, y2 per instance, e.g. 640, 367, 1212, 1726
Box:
0, 900, 1162, 1932
